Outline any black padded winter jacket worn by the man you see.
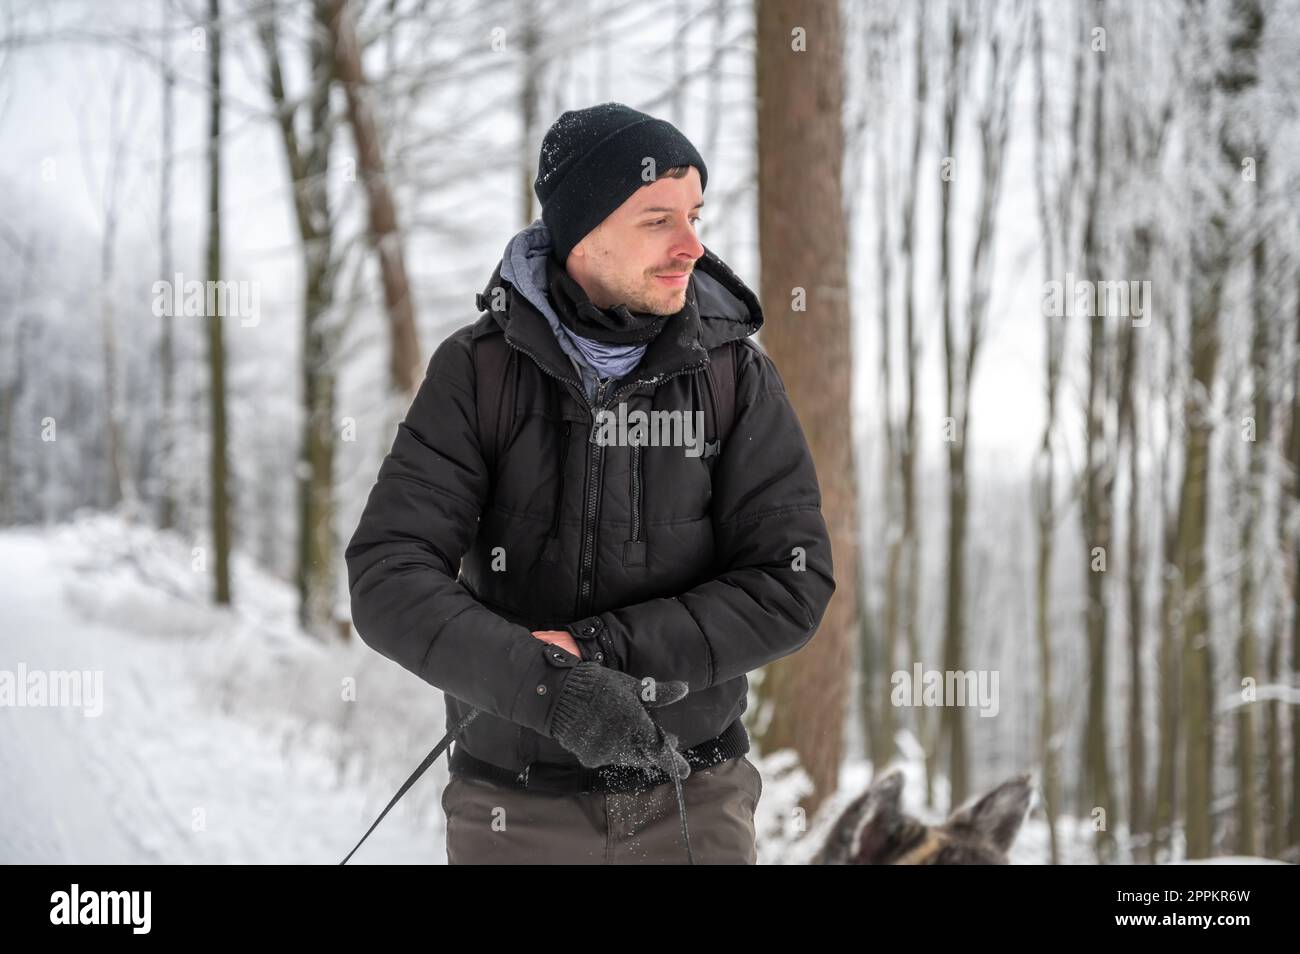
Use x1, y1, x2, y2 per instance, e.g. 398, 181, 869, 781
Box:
346, 233, 835, 779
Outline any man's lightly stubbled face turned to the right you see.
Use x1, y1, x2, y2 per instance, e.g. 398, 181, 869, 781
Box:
566, 166, 705, 315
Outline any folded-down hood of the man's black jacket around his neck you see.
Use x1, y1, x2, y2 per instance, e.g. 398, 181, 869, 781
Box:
476, 218, 763, 385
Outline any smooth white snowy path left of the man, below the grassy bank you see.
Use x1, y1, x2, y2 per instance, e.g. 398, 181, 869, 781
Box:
0, 532, 446, 864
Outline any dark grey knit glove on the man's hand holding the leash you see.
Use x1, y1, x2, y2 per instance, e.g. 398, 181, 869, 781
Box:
551, 662, 690, 779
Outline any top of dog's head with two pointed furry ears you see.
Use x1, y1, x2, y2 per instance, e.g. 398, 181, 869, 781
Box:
810, 769, 1034, 864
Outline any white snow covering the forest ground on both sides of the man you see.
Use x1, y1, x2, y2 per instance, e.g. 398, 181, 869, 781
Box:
0, 515, 1279, 864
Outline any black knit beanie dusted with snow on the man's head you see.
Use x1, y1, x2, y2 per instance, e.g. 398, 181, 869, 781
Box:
533, 103, 709, 264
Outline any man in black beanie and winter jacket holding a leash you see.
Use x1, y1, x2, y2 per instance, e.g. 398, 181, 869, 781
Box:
346, 103, 835, 864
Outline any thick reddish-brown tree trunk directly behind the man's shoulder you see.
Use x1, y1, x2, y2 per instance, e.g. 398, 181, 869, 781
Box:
755, 0, 859, 816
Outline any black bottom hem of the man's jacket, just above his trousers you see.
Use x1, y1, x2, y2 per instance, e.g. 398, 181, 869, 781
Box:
450, 719, 749, 795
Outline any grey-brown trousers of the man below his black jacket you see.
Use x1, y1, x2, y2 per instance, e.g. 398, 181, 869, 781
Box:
442, 755, 763, 864
